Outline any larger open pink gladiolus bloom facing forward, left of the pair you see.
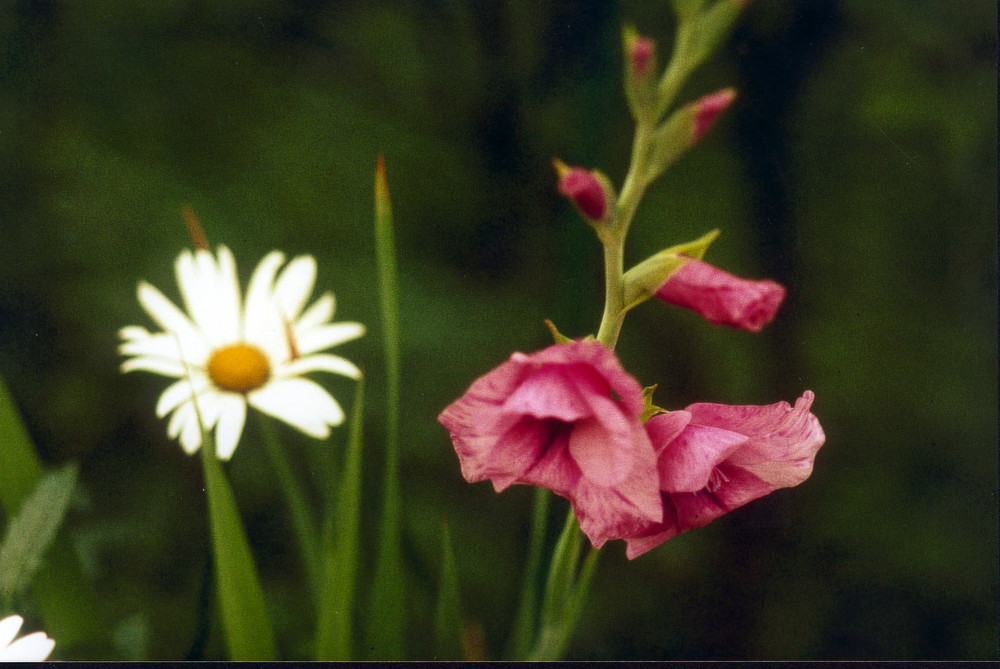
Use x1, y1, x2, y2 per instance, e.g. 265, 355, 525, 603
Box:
438, 341, 663, 548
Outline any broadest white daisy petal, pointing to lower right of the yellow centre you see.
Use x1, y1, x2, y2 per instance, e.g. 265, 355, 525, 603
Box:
247, 378, 344, 439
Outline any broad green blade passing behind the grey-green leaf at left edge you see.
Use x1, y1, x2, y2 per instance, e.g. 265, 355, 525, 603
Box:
0, 370, 107, 656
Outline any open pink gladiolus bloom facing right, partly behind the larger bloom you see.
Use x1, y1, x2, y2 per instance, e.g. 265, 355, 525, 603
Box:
625, 391, 826, 559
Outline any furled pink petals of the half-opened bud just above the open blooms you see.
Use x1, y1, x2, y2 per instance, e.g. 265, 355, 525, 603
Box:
656, 259, 785, 332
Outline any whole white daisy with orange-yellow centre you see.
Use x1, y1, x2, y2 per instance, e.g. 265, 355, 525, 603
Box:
118, 246, 365, 460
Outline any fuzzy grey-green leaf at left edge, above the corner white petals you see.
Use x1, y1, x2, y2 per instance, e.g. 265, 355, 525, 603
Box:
0, 463, 78, 608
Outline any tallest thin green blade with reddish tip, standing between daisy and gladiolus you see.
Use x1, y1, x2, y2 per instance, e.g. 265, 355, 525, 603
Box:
366, 156, 405, 660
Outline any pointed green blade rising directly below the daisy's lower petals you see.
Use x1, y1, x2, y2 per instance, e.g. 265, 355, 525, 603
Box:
201, 435, 278, 661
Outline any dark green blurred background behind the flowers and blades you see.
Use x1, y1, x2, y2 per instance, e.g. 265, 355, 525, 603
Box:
0, 0, 998, 659
